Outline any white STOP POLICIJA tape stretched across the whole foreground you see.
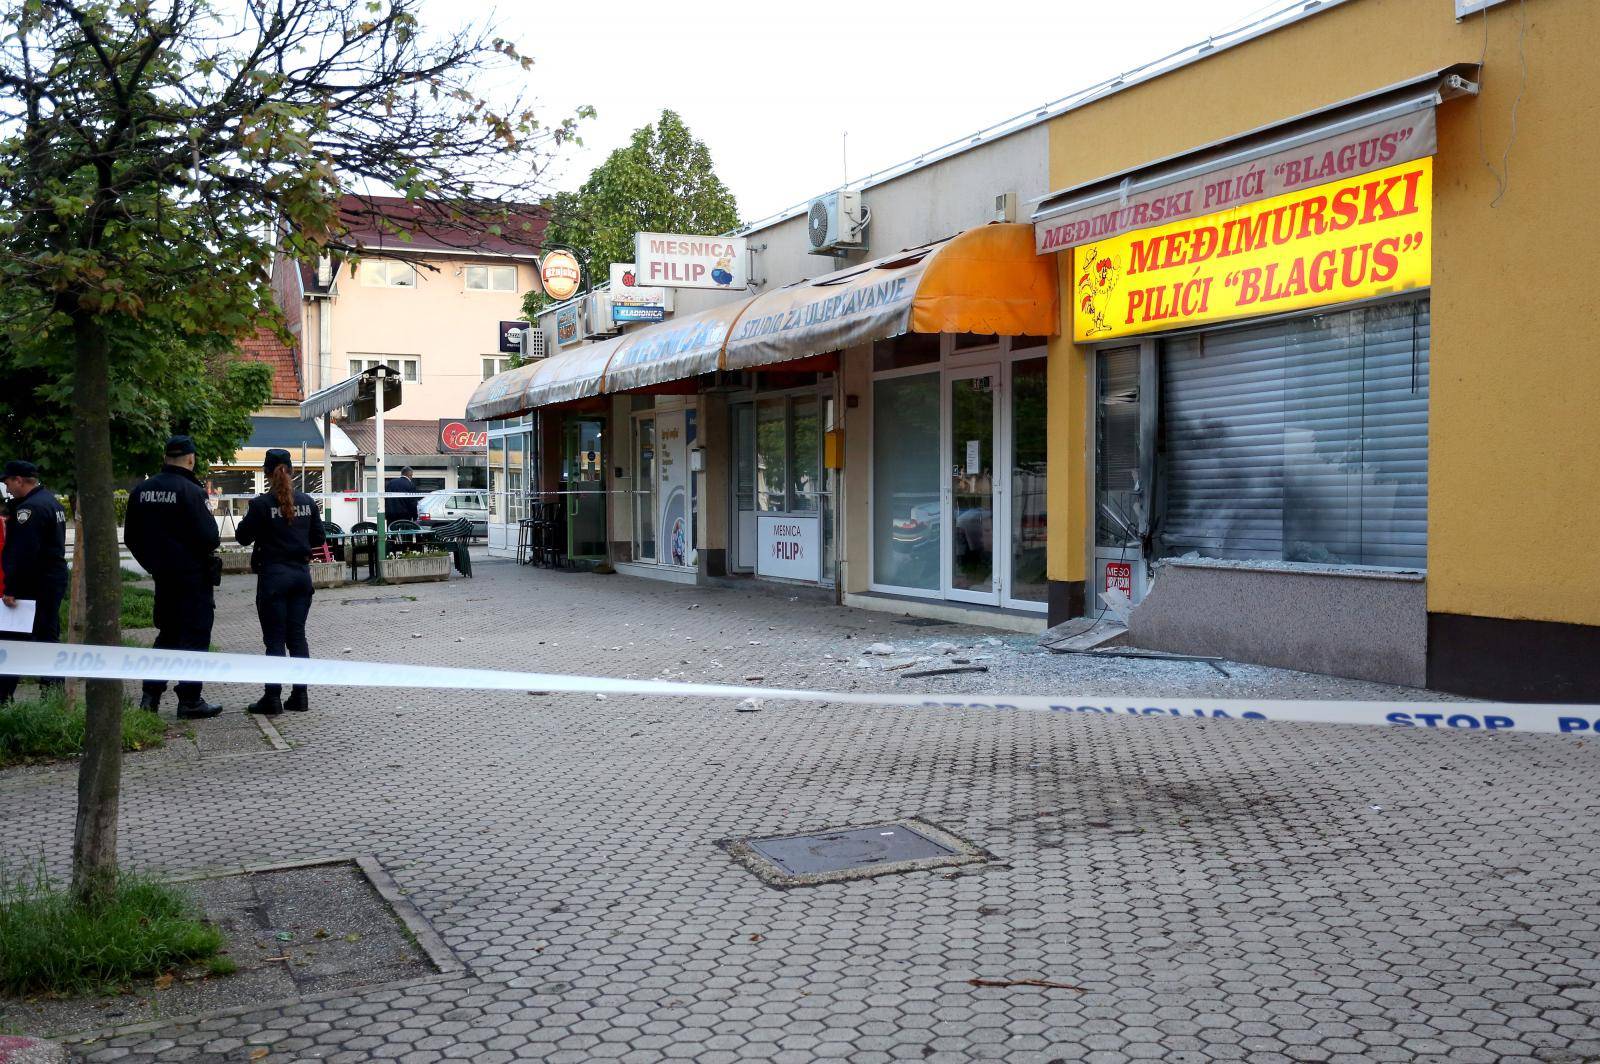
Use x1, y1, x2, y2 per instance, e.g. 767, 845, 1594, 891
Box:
0, 640, 1600, 734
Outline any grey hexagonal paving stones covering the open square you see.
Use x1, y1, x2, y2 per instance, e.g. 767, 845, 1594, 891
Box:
0, 562, 1600, 1064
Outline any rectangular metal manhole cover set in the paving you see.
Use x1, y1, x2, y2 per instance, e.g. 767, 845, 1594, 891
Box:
722, 821, 989, 886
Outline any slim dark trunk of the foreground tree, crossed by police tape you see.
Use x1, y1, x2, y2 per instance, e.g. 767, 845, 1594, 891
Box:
72, 314, 123, 904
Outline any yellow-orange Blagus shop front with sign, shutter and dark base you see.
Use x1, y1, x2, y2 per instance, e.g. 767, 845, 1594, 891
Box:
1035, 0, 1600, 699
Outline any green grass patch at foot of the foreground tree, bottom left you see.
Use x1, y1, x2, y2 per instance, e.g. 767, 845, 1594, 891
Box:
0, 867, 226, 997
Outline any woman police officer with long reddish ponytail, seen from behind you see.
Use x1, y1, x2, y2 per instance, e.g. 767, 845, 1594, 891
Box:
234, 448, 326, 715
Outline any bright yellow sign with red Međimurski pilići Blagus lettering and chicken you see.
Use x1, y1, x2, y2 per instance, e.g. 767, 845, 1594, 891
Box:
1072, 158, 1434, 342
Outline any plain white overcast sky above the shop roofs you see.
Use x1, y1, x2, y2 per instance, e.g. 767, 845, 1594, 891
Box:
464, 0, 1285, 221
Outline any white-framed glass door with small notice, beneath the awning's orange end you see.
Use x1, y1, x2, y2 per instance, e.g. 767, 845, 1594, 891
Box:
942, 365, 1003, 605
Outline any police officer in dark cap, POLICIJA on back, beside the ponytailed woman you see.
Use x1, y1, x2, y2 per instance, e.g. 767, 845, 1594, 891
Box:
123, 435, 222, 720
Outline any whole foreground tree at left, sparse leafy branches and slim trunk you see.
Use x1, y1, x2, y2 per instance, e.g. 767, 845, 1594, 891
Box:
0, 0, 581, 904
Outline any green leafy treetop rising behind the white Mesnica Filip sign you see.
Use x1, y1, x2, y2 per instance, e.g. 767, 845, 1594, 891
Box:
523, 110, 739, 320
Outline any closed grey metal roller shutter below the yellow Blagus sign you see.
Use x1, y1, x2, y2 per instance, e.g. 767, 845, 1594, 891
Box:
1158, 299, 1429, 568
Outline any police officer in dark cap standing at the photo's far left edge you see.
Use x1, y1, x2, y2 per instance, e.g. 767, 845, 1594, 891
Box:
0, 461, 67, 704
